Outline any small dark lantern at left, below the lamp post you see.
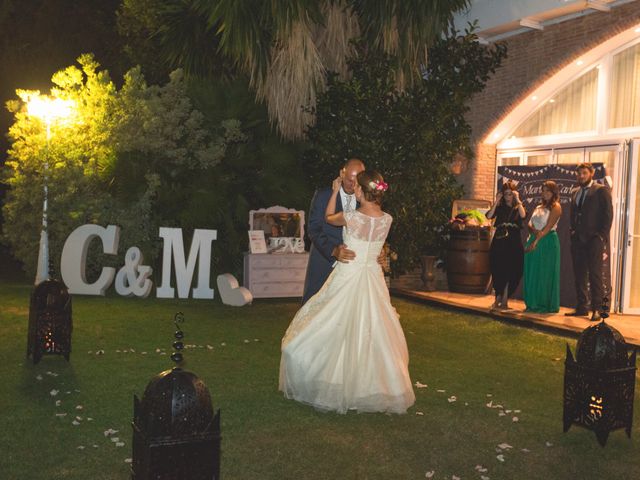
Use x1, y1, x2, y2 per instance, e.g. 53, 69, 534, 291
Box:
27, 279, 73, 363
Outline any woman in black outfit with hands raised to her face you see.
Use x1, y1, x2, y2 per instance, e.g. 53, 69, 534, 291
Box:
487, 181, 527, 309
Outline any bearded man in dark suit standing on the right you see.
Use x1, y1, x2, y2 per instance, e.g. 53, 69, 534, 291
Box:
566, 163, 613, 321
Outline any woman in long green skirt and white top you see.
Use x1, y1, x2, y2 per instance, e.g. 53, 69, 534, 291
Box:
523, 181, 562, 313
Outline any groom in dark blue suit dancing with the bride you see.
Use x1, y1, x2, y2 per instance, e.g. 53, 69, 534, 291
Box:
302, 158, 364, 304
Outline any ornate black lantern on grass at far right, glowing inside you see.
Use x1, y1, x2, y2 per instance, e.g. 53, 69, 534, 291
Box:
564, 300, 636, 447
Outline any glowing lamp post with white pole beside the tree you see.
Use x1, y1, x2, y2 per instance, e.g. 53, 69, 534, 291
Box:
27, 95, 73, 285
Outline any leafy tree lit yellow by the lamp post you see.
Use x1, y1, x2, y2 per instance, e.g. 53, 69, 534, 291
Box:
3, 55, 245, 273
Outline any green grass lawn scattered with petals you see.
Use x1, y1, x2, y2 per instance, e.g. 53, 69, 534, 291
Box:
0, 281, 640, 480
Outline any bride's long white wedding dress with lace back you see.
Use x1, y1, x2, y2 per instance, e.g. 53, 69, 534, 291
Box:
279, 210, 415, 413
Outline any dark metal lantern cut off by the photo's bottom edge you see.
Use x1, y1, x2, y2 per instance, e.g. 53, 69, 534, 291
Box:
131, 313, 220, 480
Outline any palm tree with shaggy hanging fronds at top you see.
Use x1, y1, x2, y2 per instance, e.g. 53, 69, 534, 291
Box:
124, 0, 470, 139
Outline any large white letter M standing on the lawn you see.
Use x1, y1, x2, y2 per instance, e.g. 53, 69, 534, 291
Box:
156, 227, 218, 298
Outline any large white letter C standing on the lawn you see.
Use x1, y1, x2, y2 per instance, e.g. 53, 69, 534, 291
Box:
60, 224, 120, 295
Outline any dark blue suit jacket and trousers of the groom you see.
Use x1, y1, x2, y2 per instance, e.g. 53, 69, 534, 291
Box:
302, 188, 352, 304
